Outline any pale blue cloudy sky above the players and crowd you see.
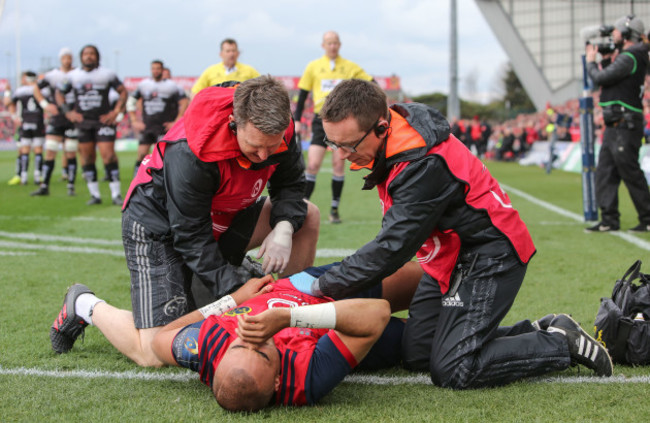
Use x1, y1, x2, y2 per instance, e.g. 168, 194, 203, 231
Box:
0, 0, 508, 101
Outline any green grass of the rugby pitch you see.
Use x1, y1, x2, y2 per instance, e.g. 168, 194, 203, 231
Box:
0, 152, 650, 422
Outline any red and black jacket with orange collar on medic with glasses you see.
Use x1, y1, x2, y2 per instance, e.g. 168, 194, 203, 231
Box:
318, 103, 535, 299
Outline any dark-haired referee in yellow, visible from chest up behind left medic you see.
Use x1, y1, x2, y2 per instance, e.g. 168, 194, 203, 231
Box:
192, 38, 260, 96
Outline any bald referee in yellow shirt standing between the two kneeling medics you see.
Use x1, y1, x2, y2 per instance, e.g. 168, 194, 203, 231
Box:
294, 31, 372, 223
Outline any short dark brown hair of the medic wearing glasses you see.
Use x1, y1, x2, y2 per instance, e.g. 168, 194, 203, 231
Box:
320, 79, 388, 129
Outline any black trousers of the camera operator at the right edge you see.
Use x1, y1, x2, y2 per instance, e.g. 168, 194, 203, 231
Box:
596, 124, 650, 226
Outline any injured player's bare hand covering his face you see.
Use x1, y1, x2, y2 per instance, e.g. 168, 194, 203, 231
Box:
235, 307, 291, 345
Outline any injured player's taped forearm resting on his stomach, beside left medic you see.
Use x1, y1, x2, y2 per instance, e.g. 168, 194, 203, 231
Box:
152, 275, 273, 366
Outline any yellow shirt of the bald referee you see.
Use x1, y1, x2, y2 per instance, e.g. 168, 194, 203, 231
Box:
298, 56, 372, 113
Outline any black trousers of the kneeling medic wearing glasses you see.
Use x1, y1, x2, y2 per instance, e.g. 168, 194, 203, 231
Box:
402, 240, 571, 389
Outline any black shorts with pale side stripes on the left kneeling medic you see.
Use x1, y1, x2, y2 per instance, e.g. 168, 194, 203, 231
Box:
122, 197, 266, 329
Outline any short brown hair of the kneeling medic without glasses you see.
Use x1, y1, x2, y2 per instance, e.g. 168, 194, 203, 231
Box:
233, 75, 291, 135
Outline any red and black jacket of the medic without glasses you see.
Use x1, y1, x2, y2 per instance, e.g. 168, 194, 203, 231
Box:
123, 86, 307, 297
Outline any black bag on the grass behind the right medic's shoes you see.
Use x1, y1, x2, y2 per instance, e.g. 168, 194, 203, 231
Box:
594, 260, 650, 365
